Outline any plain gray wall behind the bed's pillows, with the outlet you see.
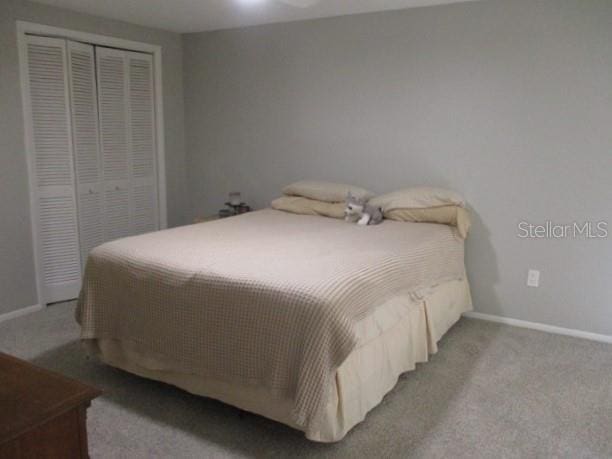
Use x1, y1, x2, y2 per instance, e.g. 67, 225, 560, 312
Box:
185, 0, 612, 334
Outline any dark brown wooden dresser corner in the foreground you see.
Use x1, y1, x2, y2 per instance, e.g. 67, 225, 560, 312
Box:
0, 353, 101, 459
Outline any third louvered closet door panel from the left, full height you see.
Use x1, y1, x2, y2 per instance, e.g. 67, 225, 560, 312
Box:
96, 47, 133, 241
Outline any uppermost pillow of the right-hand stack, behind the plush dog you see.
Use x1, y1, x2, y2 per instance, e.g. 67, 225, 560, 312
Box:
369, 186, 465, 212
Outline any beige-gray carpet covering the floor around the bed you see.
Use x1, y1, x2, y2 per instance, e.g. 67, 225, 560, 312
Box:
0, 303, 612, 458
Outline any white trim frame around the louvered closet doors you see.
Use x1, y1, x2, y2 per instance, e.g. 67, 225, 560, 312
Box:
16, 21, 168, 311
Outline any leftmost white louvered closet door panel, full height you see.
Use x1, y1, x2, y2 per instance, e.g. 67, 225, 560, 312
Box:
25, 36, 81, 303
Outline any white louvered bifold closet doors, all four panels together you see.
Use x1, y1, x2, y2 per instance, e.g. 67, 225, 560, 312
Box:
24, 35, 159, 303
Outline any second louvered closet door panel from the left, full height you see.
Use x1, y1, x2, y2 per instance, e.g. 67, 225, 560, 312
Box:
68, 41, 104, 268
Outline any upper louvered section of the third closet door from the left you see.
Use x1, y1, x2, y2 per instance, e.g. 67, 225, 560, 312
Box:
96, 47, 130, 180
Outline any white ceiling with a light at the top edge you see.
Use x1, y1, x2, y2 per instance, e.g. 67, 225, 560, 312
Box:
35, 0, 478, 32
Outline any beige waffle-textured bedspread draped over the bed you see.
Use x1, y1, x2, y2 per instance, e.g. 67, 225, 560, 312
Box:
77, 209, 464, 431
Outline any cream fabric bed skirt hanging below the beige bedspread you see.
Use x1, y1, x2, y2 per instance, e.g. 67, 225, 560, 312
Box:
83, 279, 472, 442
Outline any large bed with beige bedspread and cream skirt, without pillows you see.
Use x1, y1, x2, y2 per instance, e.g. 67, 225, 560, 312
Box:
76, 209, 471, 442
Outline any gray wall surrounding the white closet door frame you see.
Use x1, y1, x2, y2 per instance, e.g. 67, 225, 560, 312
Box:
0, 0, 188, 314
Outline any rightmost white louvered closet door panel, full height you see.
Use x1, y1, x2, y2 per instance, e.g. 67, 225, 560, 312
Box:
126, 52, 158, 234
